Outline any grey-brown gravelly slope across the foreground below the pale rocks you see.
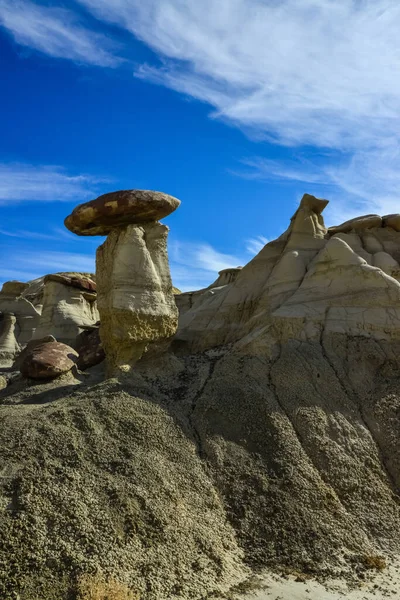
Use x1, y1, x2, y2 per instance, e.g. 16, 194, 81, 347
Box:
0, 335, 400, 600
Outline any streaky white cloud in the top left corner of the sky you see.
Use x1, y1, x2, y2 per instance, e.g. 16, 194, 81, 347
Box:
0, 0, 121, 67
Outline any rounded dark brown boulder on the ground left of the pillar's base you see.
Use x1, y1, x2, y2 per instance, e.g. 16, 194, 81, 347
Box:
20, 342, 78, 379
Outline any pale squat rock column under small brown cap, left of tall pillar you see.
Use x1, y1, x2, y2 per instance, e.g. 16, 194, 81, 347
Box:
33, 277, 99, 345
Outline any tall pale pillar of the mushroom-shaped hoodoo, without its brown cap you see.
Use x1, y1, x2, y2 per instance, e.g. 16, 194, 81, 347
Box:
96, 222, 178, 371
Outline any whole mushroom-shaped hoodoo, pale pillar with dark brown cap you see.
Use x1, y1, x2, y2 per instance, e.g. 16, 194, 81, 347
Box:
65, 190, 180, 372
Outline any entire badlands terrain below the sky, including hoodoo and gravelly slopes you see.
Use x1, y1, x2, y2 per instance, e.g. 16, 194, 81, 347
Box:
0, 190, 400, 600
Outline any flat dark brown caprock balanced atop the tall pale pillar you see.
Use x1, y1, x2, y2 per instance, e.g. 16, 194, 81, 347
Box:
64, 190, 180, 235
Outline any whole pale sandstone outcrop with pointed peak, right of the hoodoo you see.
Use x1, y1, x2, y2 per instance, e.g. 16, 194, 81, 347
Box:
176, 194, 400, 351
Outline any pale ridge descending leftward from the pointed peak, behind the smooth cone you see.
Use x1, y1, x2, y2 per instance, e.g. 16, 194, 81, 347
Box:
175, 194, 328, 351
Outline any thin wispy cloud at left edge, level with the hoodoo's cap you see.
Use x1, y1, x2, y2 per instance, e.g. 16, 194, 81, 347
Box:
0, 163, 105, 205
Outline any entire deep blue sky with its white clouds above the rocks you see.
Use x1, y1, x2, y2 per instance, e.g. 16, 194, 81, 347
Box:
0, 0, 400, 290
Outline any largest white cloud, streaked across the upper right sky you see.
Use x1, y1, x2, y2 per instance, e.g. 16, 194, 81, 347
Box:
72, 0, 400, 225
